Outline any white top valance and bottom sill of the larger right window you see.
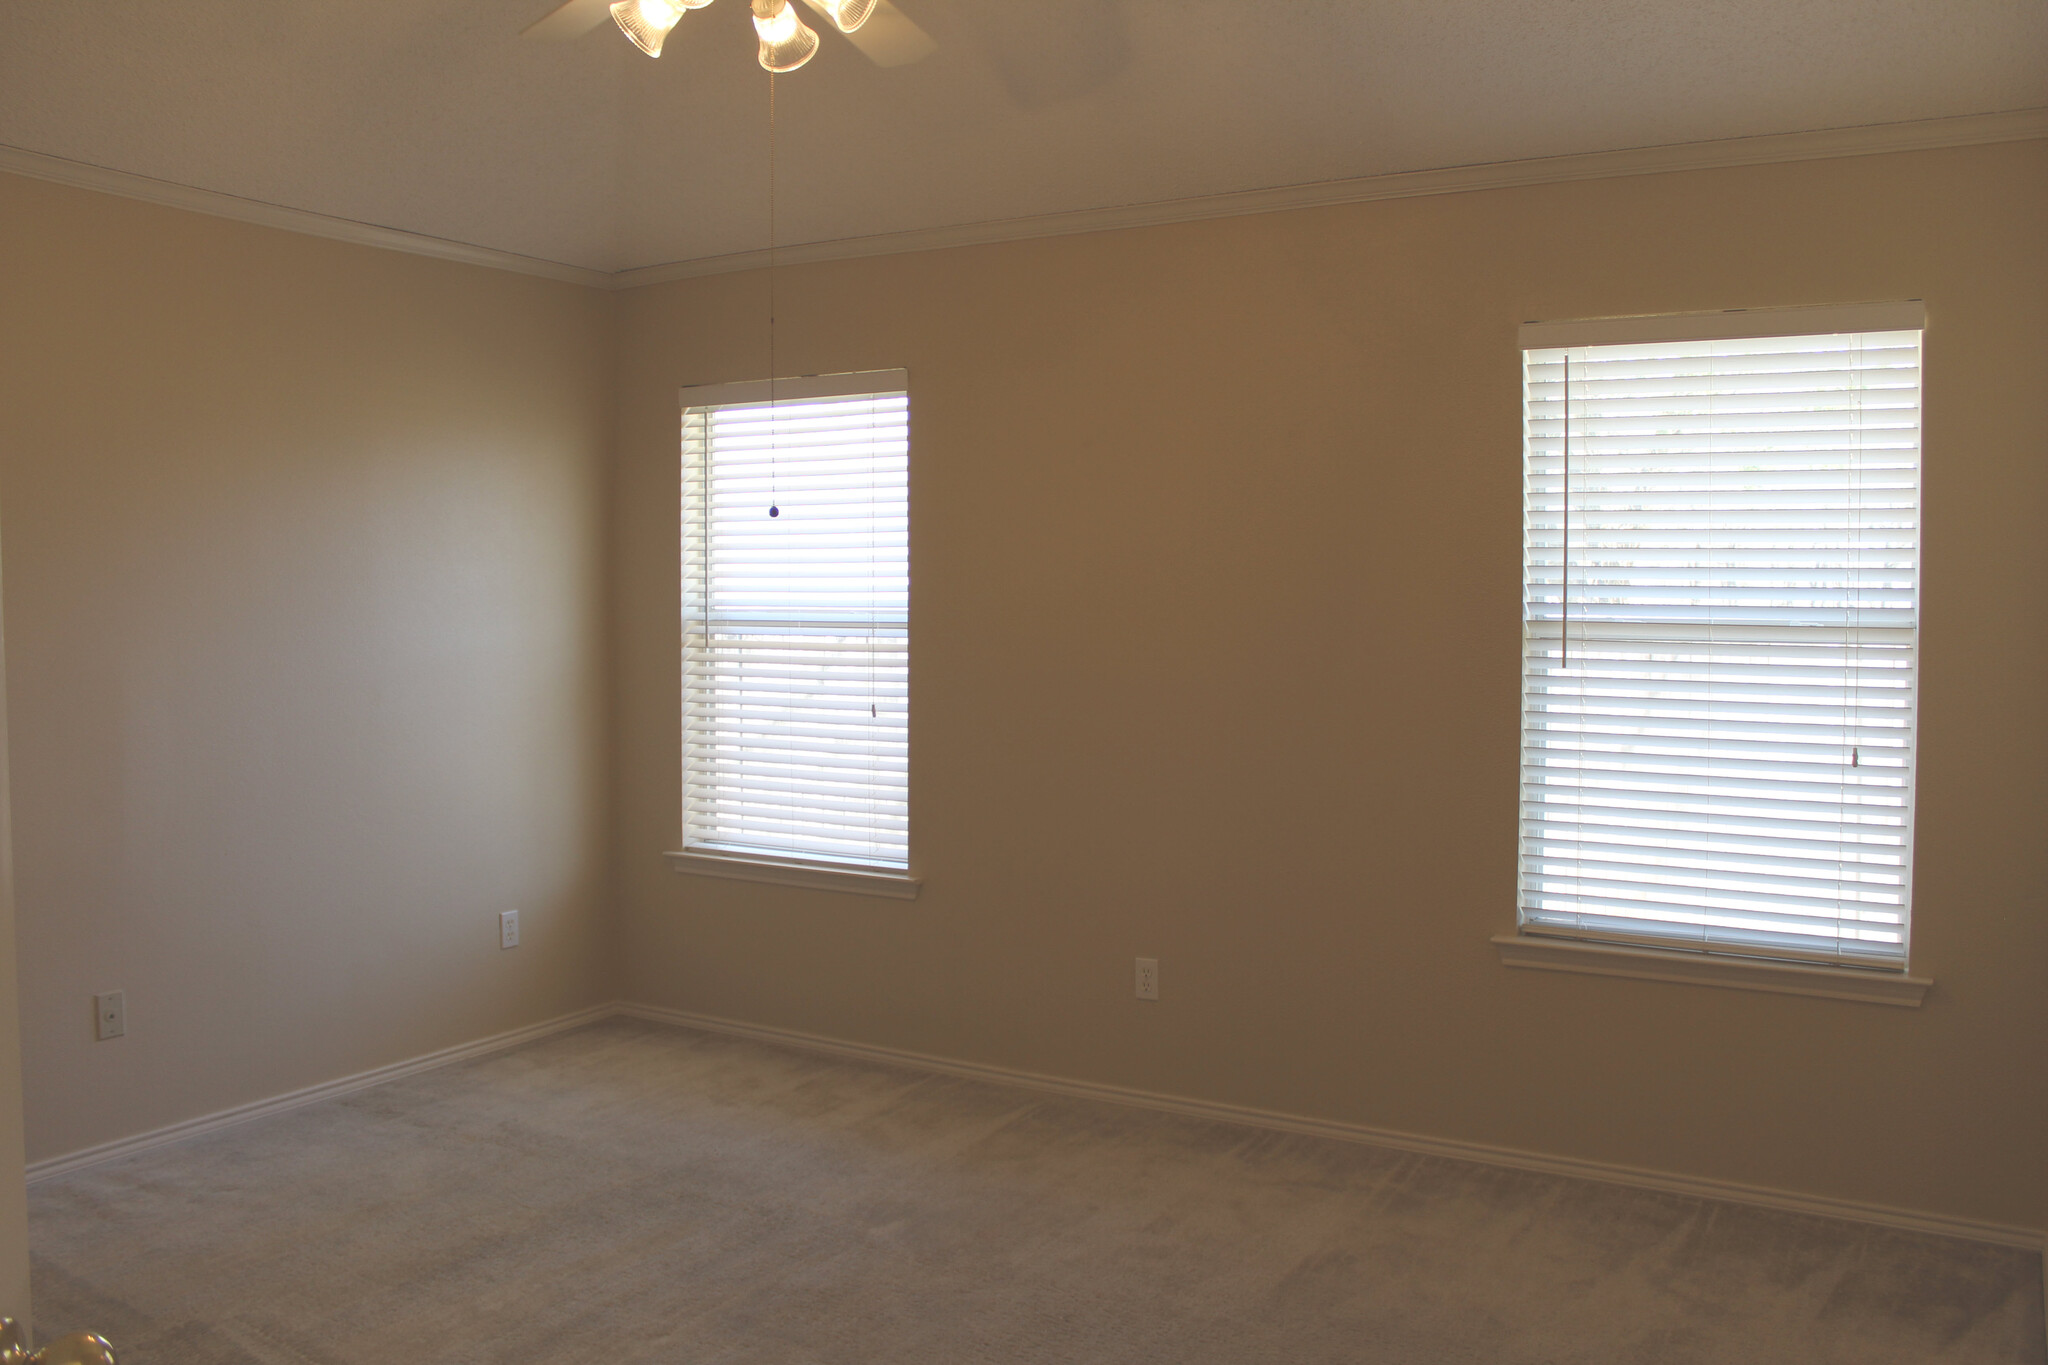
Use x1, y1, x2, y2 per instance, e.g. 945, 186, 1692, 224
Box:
1493, 299, 1935, 1009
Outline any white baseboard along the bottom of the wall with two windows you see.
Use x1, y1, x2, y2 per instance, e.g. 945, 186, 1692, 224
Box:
618, 1003, 2048, 1252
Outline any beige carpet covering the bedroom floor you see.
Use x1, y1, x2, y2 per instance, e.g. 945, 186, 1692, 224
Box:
19, 1021, 2044, 1365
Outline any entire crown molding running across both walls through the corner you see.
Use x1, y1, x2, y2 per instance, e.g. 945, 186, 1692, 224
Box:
0, 108, 2048, 289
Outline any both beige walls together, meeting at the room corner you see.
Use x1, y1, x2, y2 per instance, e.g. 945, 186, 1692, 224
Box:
0, 143, 2048, 1236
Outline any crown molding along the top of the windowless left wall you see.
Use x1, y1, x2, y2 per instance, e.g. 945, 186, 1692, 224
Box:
0, 143, 612, 289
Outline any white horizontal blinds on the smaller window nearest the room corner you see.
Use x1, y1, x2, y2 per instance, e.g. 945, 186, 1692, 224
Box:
682, 393, 909, 868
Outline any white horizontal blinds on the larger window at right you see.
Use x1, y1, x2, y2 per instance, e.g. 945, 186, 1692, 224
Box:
1522, 329, 1921, 968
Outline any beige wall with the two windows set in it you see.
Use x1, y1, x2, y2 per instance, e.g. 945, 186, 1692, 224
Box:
616, 143, 2048, 1228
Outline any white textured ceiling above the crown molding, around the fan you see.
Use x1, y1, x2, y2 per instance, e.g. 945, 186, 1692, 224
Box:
0, 0, 2048, 270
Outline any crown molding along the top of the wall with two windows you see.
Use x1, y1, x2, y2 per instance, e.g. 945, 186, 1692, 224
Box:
612, 108, 2048, 289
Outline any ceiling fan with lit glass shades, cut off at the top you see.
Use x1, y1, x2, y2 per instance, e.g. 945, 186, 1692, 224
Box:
522, 0, 938, 72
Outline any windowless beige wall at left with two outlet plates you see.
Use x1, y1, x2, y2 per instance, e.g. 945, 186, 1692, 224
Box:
0, 178, 612, 1158
